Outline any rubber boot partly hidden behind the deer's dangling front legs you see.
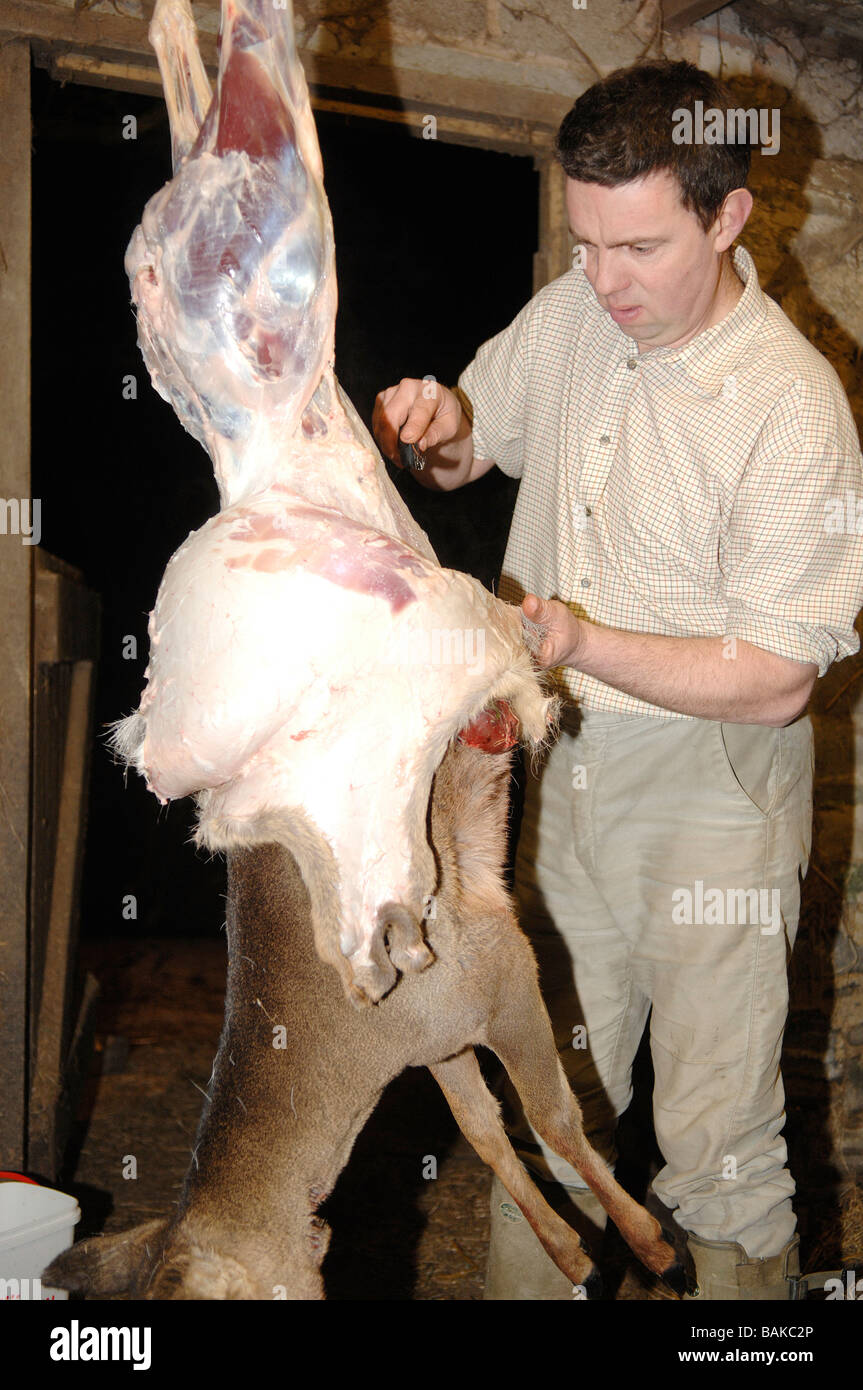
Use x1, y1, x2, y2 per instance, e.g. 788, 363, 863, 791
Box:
482, 1173, 606, 1302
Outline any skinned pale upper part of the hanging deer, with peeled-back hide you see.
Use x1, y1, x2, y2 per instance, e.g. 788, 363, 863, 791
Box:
114, 0, 553, 1002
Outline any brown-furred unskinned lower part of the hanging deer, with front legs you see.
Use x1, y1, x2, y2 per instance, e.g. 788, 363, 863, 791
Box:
43, 742, 682, 1300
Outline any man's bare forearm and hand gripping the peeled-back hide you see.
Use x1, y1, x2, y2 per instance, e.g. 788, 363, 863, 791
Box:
523, 600, 817, 726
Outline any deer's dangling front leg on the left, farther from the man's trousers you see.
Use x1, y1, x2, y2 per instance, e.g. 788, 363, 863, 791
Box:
429, 1048, 600, 1297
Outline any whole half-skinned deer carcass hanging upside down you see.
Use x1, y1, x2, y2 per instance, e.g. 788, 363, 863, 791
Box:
46, 0, 689, 1298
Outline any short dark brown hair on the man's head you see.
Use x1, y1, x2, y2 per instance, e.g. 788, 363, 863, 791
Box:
554, 60, 750, 231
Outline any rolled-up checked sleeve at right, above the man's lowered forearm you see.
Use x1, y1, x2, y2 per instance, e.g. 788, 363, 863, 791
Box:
721, 449, 863, 676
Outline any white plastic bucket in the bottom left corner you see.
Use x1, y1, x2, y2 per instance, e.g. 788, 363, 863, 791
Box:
0, 1183, 81, 1301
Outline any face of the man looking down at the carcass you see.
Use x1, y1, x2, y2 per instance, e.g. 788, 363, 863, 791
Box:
566, 171, 730, 350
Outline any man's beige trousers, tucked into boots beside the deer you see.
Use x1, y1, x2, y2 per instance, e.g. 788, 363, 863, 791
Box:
507, 708, 813, 1258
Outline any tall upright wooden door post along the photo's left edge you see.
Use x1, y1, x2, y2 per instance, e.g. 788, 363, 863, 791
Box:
0, 42, 33, 1169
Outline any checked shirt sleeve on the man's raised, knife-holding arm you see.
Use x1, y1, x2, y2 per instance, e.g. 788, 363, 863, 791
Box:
459, 303, 531, 478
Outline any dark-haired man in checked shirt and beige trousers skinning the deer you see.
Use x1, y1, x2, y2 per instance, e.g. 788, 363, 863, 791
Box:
374, 63, 863, 1298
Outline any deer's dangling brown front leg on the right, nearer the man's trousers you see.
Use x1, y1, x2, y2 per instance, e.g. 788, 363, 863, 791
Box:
486, 956, 687, 1293
